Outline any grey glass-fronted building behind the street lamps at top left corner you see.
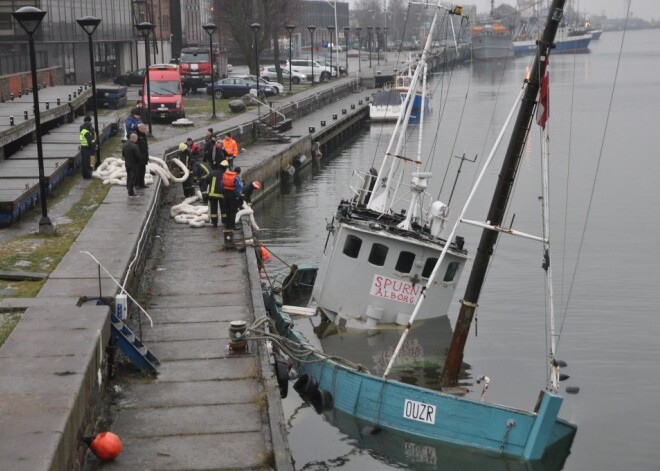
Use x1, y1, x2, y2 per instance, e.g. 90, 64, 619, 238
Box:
0, 0, 170, 83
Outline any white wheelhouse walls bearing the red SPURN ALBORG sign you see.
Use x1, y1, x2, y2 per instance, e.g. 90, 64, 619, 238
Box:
312, 223, 467, 327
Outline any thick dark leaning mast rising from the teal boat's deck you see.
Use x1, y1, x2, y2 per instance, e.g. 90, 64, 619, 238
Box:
442, 0, 566, 388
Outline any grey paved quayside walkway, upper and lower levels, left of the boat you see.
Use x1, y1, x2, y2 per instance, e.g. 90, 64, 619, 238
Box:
0, 74, 372, 471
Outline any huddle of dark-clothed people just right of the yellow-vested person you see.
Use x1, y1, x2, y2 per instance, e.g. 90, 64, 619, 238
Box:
121, 106, 149, 198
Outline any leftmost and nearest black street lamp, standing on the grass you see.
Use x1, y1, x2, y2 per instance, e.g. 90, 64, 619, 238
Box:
12, 7, 55, 235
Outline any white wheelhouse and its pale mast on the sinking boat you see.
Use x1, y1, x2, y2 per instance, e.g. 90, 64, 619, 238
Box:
312, 10, 468, 329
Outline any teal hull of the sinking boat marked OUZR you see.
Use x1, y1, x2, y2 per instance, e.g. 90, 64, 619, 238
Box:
268, 295, 577, 460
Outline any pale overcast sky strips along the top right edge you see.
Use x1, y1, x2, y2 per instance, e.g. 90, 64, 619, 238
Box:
470, 0, 660, 20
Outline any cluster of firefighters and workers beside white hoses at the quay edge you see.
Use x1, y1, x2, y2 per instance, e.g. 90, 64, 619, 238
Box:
178, 128, 261, 229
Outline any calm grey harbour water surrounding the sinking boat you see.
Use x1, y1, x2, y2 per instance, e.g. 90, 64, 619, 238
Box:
255, 30, 660, 470
